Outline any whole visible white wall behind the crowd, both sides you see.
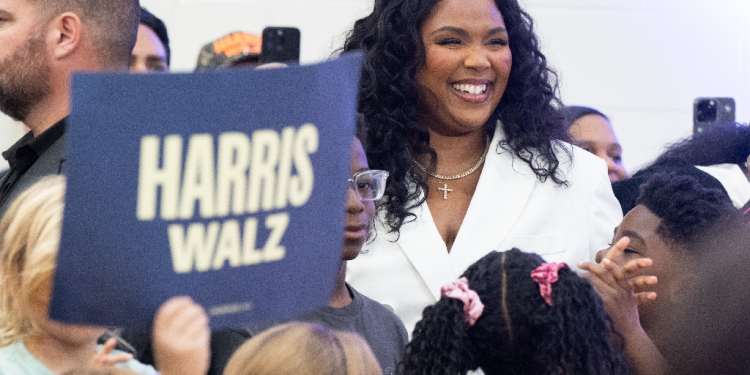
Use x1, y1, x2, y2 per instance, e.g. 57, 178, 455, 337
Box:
0, 0, 750, 171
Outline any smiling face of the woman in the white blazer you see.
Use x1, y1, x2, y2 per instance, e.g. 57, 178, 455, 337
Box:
417, 0, 513, 134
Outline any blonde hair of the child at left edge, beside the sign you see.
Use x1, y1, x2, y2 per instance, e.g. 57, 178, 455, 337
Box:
0, 176, 65, 347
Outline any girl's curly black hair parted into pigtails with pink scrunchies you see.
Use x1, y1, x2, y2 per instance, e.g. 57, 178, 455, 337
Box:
398, 249, 627, 375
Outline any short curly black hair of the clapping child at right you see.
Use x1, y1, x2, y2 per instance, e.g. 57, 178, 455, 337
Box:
636, 172, 742, 245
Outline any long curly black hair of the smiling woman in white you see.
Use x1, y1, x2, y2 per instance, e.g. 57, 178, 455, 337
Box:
343, 0, 571, 231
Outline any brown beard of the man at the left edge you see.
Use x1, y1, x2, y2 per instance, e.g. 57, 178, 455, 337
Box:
0, 32, 50, 122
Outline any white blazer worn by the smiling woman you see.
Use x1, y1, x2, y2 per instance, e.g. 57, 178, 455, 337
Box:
346, 126, 622, 333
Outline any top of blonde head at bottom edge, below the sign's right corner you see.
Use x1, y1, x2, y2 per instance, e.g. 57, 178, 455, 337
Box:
224, 322, 383, 375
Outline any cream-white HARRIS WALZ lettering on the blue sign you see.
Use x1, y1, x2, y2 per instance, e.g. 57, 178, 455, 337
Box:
136, 124, 319, 273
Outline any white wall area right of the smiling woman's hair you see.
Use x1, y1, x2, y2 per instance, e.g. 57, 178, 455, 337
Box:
525, 0, 750, 172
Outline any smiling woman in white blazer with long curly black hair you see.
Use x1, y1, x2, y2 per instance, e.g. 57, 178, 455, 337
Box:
344, 0, 621, 336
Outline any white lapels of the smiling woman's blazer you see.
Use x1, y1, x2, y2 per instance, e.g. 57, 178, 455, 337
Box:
398, 123, 538, 301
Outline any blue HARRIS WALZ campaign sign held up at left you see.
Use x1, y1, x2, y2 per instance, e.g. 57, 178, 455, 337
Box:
50, 54, 361, 329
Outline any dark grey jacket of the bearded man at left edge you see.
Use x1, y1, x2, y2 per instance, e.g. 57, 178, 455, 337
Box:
0, 134, 65, 217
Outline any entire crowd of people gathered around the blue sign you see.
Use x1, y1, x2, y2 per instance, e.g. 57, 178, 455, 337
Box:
0, 0, 750, 375
